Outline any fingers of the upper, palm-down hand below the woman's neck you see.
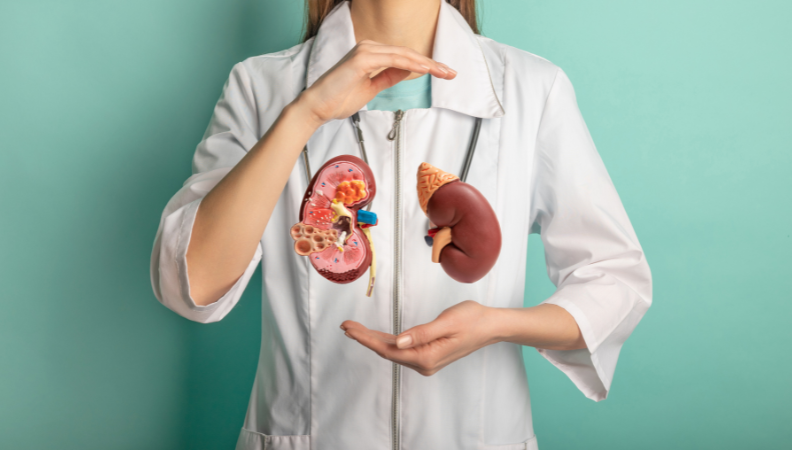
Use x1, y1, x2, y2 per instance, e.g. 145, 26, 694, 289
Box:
353, 41, 456, 80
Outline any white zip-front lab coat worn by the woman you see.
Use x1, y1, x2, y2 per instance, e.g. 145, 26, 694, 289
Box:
151, 2, 652, 450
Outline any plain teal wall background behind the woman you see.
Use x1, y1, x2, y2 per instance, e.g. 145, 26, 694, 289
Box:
0, 0, 792, 450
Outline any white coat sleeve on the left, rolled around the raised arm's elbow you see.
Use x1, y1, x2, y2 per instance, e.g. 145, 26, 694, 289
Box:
151, 63, 262, 323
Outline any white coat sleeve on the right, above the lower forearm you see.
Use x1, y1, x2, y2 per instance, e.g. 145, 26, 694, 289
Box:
530, 70, 652, 401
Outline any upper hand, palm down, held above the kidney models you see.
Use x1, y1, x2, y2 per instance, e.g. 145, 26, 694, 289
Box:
295, 40, 456, 126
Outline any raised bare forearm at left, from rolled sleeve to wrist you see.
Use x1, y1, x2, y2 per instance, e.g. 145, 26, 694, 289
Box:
187, 101, 319, 305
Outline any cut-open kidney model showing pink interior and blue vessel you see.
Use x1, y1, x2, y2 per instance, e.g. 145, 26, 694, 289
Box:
291, 155, 377, 297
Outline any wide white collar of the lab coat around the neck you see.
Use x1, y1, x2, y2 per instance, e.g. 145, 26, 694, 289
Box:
306, 1, 504, 119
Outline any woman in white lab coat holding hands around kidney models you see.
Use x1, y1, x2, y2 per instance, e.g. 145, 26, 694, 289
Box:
151, 0, 652, 450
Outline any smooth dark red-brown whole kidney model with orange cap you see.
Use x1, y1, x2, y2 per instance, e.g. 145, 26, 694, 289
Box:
418, 163, 501, 283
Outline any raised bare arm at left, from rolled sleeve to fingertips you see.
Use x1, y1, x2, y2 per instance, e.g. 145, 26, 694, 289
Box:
187, 41, 456, 305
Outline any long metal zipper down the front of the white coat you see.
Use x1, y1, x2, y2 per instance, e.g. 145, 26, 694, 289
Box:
388, 110, 404, 450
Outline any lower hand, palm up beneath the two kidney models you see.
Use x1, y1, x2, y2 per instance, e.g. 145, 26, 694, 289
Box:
341, 300, 499, 376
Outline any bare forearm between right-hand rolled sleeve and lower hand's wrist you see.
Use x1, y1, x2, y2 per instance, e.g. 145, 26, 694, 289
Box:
489, 304, 586, 350
